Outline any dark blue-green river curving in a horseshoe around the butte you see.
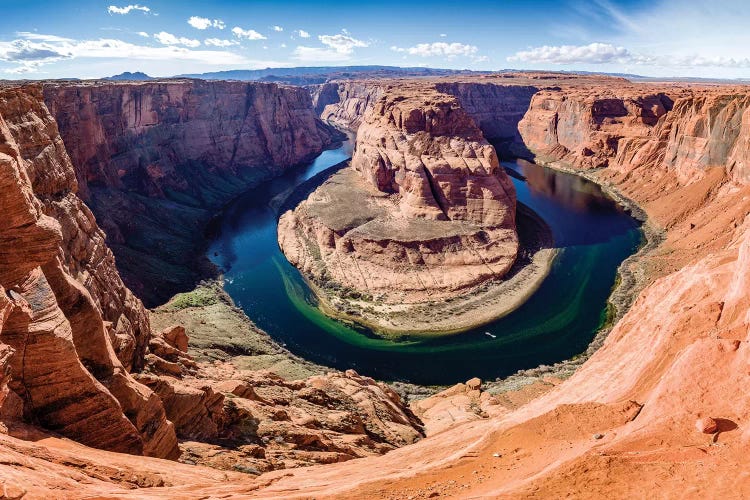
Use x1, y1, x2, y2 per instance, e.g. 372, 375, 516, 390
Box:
209, 144, 641, 384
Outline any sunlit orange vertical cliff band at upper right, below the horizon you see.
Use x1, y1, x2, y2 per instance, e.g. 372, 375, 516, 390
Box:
519, 87, 750, 184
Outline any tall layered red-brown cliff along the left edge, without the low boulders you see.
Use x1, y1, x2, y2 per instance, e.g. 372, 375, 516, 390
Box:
0, 86, 179, 458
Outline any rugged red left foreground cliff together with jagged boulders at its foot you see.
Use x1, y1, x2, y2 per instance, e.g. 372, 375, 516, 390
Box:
0, 80, 428, 474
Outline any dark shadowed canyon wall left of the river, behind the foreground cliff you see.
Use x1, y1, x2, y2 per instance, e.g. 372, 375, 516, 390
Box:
44, 80, 341, 306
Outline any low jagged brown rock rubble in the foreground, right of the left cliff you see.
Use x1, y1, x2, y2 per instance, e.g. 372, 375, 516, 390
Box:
139, 364, 422, 473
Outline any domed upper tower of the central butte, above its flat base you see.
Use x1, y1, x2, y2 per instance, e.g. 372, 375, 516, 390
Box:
352, 90, 515, 228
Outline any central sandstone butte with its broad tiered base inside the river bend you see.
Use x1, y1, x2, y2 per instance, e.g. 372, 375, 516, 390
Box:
279, 86, 518, 312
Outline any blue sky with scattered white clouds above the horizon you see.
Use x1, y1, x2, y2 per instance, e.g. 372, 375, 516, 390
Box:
0, 0, 750, 79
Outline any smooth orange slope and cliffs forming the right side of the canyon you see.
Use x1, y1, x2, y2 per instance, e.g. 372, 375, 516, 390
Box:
248, 81, 750, 498
